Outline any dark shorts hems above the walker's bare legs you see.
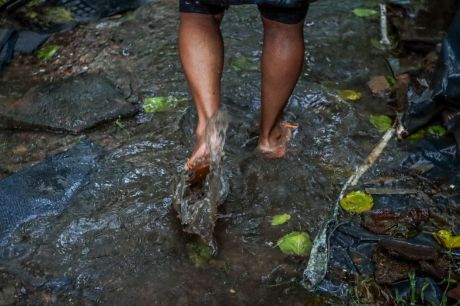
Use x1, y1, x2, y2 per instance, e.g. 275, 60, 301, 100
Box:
179, 0, 308, 24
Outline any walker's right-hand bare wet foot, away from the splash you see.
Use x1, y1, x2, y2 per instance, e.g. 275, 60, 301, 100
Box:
257, 122, 298, 159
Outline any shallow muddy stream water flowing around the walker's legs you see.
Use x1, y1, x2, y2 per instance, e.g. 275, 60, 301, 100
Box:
0, 0, 442, 305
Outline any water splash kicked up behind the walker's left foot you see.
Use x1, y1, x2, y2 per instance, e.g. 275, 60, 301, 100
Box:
173, 111, 229, 254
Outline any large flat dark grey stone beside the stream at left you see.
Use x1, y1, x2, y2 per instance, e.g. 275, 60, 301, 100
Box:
0, 74, 136, 134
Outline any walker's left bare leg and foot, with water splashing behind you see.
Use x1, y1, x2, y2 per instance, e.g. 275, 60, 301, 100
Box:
179, 13, 224, 167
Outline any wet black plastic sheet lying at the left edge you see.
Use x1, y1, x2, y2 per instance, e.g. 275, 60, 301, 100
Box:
0, 141, 102, 242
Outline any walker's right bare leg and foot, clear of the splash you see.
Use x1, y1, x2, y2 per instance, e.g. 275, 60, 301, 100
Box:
258, 18, 304, 157
